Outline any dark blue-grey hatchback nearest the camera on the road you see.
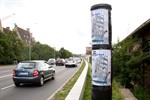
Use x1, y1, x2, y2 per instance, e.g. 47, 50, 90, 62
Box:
13, 60, 55, 86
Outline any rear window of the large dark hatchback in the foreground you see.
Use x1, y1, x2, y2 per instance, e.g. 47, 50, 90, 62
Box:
17, 62, 35, 69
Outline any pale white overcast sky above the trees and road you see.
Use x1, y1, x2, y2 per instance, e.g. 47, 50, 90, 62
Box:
0, 0, 150, 54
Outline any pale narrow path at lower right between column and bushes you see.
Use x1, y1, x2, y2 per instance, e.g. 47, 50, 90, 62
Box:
121, 88, 138, 100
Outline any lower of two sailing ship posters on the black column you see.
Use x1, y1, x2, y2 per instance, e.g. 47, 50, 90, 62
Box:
92, 49, 111, 86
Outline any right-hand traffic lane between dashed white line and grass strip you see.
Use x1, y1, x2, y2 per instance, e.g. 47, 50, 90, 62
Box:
0, 66, 79, 100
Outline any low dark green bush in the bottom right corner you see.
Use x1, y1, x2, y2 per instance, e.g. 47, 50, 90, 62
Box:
132, 86, 150, 100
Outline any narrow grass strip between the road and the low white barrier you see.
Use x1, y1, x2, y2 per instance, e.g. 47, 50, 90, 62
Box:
51, 60, 85, 100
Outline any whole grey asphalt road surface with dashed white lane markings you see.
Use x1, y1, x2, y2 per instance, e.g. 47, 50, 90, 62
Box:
0, 65, 80, 100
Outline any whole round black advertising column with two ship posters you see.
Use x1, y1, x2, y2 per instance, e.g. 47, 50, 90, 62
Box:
91, 4, 112, 100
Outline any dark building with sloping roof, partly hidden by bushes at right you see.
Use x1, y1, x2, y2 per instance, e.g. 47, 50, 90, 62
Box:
123, 19, 150, 91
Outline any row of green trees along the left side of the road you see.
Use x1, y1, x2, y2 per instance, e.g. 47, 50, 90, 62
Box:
0, 31, 73, 65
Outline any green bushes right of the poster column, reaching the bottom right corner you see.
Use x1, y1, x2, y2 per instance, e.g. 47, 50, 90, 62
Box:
112, 37, 150, 100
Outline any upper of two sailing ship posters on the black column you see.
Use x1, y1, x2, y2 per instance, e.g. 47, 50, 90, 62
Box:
91, 9, 109, 45
